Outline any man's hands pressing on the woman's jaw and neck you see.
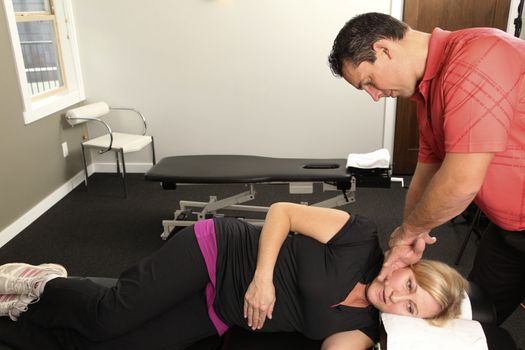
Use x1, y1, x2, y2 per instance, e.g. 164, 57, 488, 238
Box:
377, 226, 436, 281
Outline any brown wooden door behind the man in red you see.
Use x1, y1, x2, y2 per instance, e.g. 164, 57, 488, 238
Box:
393, 0, 510, 175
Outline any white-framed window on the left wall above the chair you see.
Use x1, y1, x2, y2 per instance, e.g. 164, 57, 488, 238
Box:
3, 0, 84, 124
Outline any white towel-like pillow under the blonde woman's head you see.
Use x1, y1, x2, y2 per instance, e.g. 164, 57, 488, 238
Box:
381, 297, 488, 350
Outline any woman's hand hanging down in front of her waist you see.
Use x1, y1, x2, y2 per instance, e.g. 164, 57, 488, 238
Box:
244, 277, 275, 330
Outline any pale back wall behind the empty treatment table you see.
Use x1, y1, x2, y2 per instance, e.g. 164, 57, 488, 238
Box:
73, 0, 391, 163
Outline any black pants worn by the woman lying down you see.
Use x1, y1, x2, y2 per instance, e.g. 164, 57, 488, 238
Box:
13, 227, 217, 349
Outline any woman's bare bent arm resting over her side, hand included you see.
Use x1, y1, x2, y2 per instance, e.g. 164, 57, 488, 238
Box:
244, 203, 350, 330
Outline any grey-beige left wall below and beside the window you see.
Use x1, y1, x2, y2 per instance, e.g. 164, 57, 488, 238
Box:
0, 6, 82, 235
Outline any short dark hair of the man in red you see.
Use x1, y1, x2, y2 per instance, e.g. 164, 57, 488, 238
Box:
328, 12, 408, 76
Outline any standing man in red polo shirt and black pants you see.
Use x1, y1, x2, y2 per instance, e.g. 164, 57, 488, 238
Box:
329, 13, 525, 323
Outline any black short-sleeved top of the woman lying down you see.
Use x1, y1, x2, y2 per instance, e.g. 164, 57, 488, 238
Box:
214, 216, 383, 342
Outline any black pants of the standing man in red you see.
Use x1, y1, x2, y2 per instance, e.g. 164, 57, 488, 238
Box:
469, 223, 525, 324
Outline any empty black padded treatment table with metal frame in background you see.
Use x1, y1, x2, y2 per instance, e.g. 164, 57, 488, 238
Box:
146, 155, 390, 239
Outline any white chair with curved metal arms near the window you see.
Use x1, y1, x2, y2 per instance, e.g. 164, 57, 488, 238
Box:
66, 102, 156, 197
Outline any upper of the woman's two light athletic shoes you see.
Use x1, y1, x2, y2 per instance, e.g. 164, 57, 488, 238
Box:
0, 263, 67, 299
